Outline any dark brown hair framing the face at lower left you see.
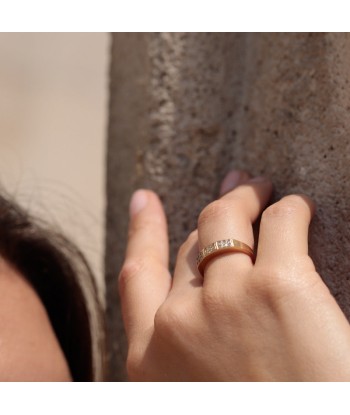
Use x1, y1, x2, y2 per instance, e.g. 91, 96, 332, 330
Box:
0, 195, 104, 381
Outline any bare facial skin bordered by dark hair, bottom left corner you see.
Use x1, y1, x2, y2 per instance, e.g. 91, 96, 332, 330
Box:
0, 257, 71, 382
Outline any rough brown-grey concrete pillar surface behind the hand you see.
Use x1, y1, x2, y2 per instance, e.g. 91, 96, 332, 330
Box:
106, 33, 350, 379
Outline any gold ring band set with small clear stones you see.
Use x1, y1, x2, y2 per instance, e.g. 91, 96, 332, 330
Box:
197, 238, 254, 275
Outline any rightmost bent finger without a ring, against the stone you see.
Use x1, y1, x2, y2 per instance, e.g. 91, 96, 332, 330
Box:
256, 195, 315, 269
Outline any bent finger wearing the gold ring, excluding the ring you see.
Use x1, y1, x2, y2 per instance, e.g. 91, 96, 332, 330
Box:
198, 177, 272, 285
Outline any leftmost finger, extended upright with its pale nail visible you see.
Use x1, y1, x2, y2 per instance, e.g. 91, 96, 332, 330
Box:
119, 190, 171, 341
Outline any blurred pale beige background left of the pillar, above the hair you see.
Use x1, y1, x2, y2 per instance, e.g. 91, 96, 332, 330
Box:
0, 33, 109, 298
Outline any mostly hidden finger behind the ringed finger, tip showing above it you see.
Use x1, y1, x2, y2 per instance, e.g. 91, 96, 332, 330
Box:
171, 170, 250, 294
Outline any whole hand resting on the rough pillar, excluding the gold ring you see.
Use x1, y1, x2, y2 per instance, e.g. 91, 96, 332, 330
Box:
119, 172, 350, 381
